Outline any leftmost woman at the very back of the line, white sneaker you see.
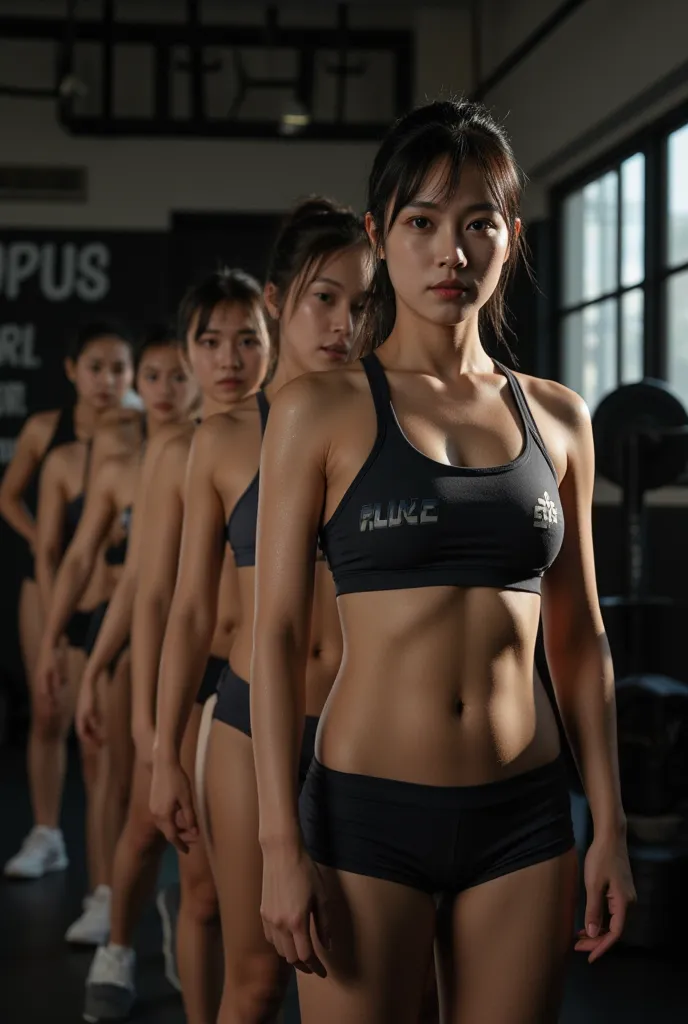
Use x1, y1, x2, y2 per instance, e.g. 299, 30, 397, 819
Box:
2, 322, 133, 879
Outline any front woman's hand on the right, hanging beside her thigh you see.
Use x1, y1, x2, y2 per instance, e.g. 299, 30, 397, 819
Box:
575, 836, 636, 964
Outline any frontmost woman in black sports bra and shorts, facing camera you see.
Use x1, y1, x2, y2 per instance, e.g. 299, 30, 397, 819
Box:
251, 101, 634, 1024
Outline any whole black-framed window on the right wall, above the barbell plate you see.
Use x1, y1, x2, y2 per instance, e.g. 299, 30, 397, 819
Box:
555, 108, 688, 412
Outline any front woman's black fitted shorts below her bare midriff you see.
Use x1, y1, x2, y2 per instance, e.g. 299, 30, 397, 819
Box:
299, 757, 573, 895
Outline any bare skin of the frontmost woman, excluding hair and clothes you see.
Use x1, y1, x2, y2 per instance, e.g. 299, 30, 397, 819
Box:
251, 162, 633, 1024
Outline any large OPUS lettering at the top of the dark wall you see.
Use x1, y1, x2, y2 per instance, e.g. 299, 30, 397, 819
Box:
0, 242, 111, 302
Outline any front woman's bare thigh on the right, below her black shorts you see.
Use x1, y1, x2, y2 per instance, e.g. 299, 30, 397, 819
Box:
440, 850, 577, 1024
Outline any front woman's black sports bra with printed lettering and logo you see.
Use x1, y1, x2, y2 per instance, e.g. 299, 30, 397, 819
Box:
320, 354, 564, 594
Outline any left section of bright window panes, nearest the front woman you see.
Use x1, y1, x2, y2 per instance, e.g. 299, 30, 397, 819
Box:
560, 153, 645, 409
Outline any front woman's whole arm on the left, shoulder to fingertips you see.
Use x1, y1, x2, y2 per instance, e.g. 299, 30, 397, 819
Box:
251, 374, 329, 971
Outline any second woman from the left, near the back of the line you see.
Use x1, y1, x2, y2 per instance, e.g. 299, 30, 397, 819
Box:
32, 328, 197, 945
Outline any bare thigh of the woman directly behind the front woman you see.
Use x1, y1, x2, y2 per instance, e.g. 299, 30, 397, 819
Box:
206, 720, 289, 986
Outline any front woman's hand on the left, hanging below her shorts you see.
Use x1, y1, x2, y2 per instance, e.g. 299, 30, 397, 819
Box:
260, 844, 331, 977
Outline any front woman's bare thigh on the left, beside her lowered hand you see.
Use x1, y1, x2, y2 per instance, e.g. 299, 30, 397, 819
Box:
297, 865, 435, 1024
